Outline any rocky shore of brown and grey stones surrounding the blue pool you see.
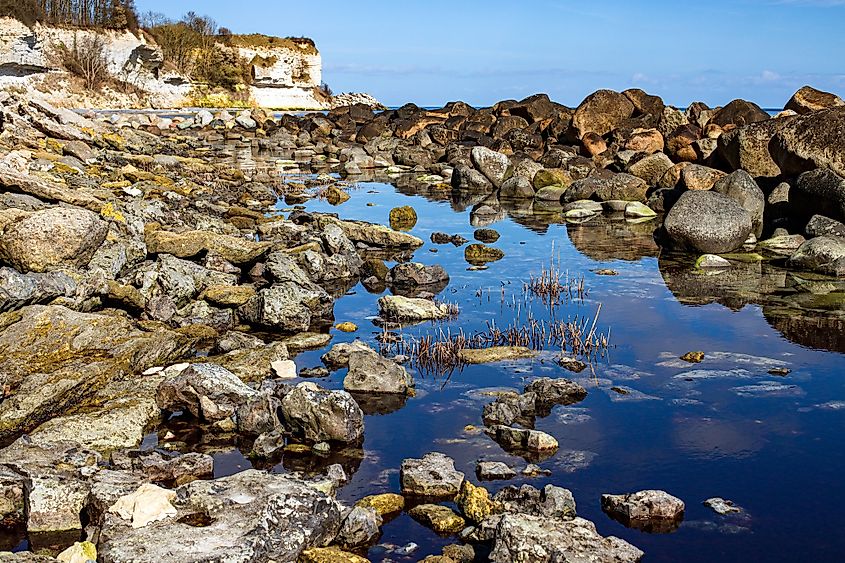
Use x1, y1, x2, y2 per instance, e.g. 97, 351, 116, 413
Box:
0, 88, 845, 563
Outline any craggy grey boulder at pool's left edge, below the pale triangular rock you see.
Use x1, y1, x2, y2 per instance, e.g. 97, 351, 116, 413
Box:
282, 381, 364, 444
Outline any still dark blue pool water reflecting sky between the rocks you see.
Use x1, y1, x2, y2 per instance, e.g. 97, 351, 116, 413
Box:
206, 174, 845, 562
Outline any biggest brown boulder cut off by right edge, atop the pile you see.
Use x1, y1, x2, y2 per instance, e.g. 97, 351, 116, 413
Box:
769, 107, 845, 177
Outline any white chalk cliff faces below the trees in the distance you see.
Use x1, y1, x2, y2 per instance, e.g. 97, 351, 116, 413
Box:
0, 18, 328, 110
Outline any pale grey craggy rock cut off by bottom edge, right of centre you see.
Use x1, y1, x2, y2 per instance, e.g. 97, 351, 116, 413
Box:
490, 514, 644, 563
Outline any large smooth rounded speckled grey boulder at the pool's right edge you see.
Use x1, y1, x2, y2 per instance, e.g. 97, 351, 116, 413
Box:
663, 191, 753, 254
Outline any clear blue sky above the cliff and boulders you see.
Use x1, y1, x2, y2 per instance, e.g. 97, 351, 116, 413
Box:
136, 0, 845, 108
